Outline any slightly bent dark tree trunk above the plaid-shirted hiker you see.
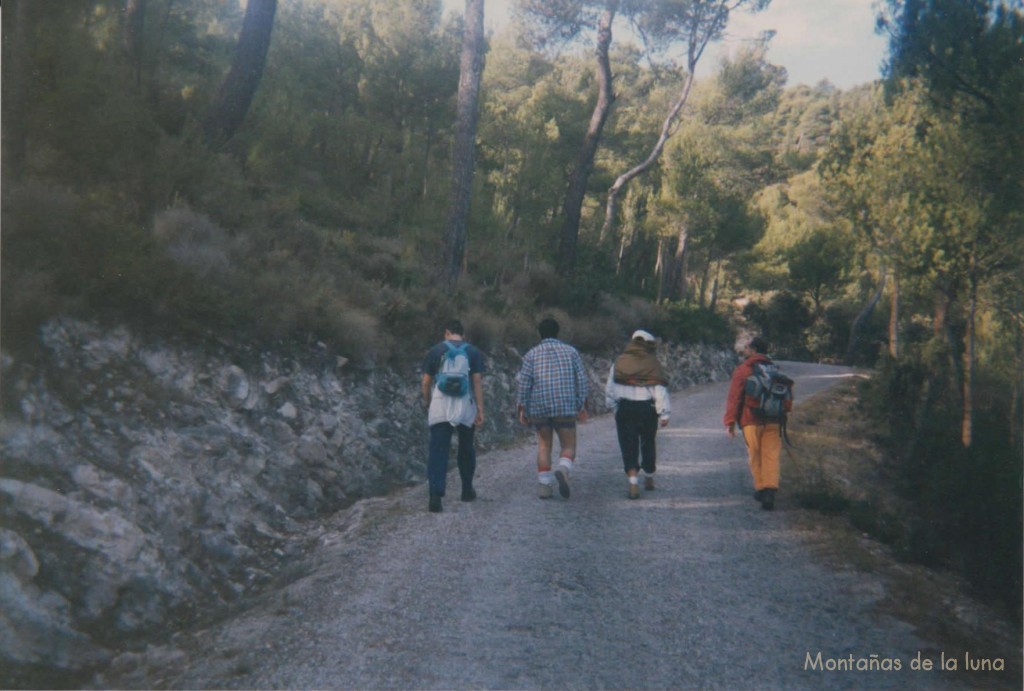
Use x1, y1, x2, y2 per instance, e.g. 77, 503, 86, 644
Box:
557, 0, 618, 276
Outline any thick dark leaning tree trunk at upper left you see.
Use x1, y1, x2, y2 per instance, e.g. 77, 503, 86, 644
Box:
205, 0, 278, 145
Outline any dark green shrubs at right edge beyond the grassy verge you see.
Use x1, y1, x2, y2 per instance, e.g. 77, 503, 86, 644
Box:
862, 354, 1024, 611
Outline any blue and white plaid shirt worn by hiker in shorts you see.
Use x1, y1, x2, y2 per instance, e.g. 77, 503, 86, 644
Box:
515, 338, 588, 418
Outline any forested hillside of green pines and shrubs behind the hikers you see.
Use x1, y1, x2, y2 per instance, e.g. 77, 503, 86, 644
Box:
2, 0, 1024, 626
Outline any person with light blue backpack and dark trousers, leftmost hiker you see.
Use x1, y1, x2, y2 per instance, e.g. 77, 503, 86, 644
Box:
421, 319, 486, 513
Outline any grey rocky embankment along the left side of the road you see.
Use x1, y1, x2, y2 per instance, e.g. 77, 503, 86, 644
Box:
0, 319, 735, 688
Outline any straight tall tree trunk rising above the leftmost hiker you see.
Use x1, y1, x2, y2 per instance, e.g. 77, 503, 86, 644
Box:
441, 0, 483, 288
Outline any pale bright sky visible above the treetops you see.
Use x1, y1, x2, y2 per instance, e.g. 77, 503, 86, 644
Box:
444, 0, 886, 89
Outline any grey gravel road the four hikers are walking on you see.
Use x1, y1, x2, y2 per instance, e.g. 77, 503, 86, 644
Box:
130, 363, 963, 689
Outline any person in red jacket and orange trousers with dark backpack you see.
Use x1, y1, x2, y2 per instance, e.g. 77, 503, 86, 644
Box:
723, 336, 794, 511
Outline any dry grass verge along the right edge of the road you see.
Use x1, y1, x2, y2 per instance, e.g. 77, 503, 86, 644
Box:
783, 380, 1022, 689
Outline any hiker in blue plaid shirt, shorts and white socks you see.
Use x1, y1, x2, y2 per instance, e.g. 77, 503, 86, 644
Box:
516, 317, 588, 499
